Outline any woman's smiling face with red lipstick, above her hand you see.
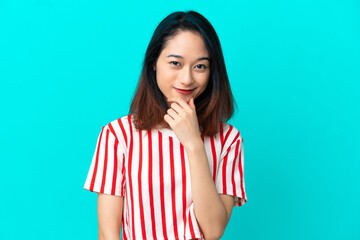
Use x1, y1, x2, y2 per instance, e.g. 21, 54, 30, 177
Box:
153, 30, 210, 106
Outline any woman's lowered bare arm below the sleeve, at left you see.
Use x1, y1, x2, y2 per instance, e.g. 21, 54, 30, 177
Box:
97, 193, 124, 240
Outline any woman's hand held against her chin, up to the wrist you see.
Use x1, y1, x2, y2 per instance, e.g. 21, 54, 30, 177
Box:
164, 98, 202, 149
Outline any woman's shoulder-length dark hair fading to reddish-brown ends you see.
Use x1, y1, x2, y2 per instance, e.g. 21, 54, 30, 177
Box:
129, 11, 236, 136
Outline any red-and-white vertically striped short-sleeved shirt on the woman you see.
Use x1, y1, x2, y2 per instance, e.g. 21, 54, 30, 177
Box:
84, 114, 247, 240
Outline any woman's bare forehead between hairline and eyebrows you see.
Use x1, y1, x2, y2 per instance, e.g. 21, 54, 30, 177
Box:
162, 31, 208, 57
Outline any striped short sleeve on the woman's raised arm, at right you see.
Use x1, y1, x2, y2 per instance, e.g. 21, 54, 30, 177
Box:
215, 126, 247, 207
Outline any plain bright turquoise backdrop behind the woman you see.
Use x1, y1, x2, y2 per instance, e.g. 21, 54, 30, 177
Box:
0, 0, 360, 240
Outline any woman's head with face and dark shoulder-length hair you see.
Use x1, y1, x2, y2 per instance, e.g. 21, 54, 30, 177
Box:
130, 11, 234, 136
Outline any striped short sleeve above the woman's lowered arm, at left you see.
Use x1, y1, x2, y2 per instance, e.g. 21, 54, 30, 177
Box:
84, 124, 125, 196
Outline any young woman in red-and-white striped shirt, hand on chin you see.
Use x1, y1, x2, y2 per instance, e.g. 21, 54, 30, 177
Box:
84, 11, 247, 240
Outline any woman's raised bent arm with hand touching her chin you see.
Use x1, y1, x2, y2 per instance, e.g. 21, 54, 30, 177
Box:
164, 98, 234, 240
